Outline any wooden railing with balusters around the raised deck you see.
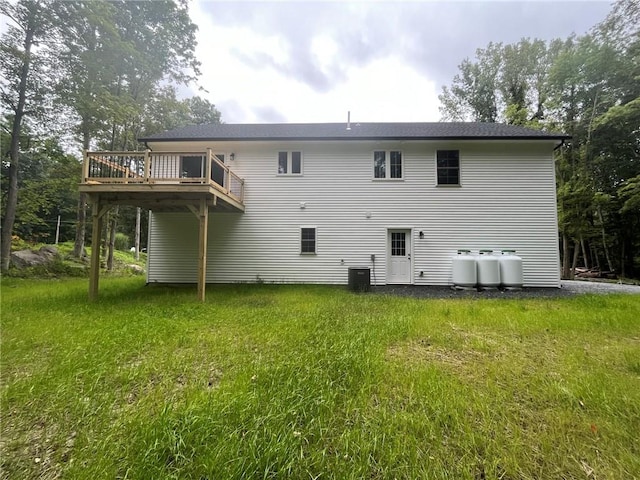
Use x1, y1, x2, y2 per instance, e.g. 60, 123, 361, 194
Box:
82, 150, 244, 202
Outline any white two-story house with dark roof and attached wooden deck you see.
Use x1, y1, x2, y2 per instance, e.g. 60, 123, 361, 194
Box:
81, 123, 568, 298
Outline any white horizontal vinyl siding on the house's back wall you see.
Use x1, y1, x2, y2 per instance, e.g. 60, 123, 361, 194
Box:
148, 141, 560, 287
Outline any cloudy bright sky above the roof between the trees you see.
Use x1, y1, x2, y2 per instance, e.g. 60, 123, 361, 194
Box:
190, 0, 610, 123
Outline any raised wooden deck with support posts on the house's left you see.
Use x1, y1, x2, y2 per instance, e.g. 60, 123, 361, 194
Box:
80, 150, 244, 301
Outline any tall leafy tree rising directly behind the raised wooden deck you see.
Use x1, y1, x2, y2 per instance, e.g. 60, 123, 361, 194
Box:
54, 0, 199, 262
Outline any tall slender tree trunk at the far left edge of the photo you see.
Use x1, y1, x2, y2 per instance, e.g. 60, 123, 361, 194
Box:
0, 16, 38, 272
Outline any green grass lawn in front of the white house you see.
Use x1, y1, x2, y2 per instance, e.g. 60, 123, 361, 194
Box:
0, 278, 640, 480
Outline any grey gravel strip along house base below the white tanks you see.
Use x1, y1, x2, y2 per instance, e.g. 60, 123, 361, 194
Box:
371, 280, 640, 298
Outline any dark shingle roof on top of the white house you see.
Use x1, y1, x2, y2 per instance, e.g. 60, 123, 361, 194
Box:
139, 122, 570, 142
